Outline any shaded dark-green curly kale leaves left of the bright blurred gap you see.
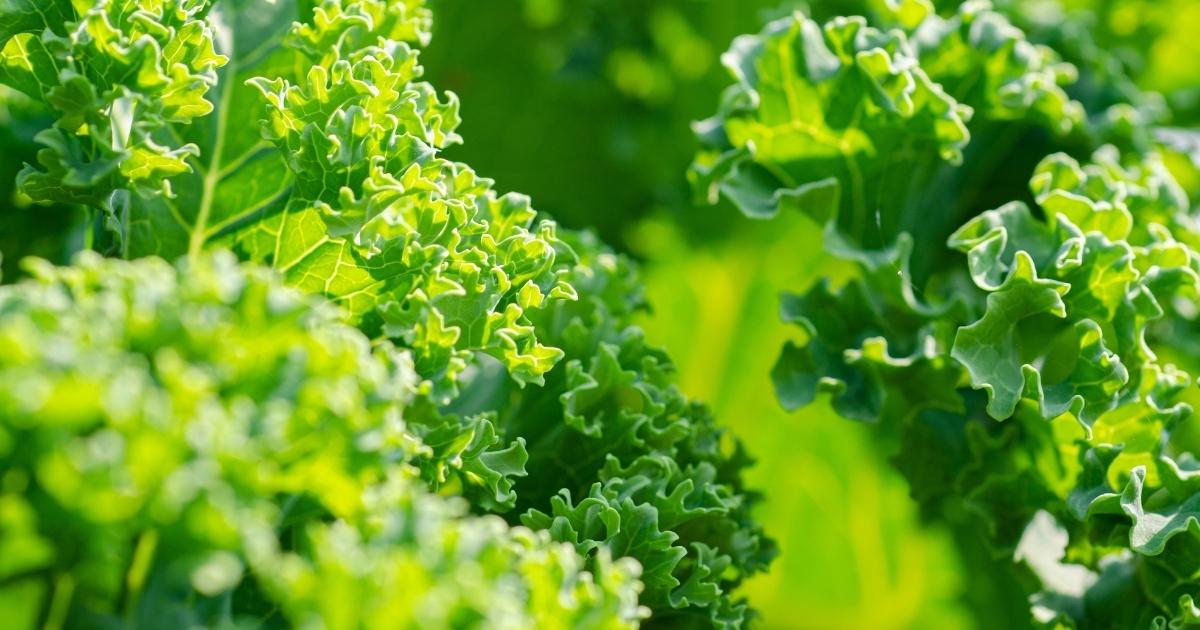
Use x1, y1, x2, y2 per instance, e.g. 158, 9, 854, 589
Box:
456, 229, 774, 626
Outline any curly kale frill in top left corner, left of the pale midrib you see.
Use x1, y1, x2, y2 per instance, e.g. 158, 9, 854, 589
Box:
0, 1, 226, 204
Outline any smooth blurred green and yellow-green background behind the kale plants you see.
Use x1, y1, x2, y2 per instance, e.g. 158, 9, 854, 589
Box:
0, 0, 1200, 628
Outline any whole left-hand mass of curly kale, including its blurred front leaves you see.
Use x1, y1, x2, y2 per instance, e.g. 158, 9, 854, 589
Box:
0, 0, 773, 628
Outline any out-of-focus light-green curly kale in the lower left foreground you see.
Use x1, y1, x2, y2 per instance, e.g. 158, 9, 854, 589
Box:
0, 254, 641, 628
